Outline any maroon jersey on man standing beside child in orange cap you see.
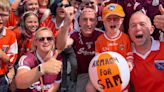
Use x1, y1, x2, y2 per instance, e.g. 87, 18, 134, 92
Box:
71, 30, 103, 74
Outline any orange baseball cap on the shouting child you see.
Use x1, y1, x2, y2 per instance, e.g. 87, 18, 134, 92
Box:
102, 3, 125, 19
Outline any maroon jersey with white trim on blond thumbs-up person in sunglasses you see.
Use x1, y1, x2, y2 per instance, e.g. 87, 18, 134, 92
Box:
17, 52, 61, 92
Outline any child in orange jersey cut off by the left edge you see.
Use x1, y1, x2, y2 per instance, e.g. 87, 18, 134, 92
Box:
0, 0, 18, 92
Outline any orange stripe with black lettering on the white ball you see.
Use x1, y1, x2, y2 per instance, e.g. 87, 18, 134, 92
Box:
96, 53, 122, 92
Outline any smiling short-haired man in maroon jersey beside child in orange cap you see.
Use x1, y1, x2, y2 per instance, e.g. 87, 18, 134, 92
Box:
71, 8, 102, 92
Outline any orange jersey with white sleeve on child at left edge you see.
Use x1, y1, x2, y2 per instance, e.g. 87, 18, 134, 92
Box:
0, 28, 18, 75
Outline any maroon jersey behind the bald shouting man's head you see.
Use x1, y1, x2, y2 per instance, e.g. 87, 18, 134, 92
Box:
122, 0, 164, 33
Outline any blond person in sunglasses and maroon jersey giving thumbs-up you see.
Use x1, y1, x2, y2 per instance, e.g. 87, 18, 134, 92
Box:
16, 27, 62, 92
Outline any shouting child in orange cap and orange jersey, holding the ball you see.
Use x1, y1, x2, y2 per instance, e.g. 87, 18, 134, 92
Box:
86, 3, 133, 92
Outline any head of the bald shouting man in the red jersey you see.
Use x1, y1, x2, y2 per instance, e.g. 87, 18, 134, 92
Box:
128, 13, 154, 46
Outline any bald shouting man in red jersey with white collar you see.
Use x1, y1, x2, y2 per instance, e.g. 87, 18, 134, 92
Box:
128, 11, 164, 92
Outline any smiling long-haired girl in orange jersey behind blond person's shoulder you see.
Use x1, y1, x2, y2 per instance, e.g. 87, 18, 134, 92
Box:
13, 12, 39, 59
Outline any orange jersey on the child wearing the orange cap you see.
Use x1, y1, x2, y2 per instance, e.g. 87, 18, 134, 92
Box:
95, 32, 132, 58
